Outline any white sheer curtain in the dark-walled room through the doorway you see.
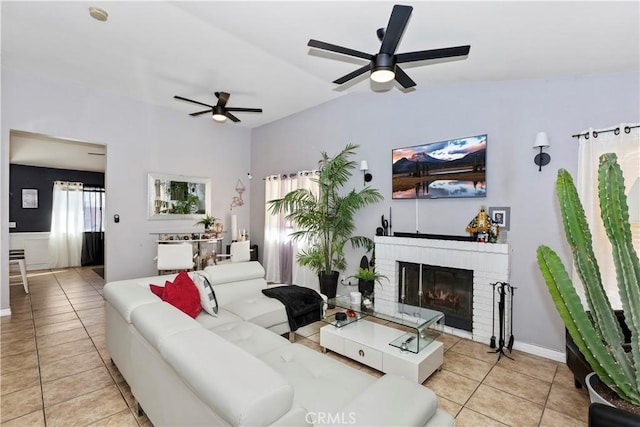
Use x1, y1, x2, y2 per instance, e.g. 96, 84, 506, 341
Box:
49, 181, 84, 268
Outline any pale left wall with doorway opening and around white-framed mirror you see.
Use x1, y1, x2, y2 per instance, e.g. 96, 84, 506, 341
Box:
0, 70, 251, 310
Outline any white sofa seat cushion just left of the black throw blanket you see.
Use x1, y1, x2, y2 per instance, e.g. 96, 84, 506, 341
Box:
224, 291, 288, 328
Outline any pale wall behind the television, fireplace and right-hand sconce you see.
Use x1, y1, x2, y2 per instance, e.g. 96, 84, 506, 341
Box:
251, 74, 640, 351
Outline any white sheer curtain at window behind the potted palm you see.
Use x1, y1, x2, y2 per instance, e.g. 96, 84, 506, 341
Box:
264, 171, 318, 288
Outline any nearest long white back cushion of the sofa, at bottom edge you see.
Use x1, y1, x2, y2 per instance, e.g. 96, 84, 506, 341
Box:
160, 328, 293, 426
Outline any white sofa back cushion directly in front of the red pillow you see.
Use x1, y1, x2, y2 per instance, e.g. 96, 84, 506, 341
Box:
131, 301, 202, 351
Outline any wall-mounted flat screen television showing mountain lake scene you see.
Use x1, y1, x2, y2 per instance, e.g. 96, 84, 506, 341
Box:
391, 135, 487, 199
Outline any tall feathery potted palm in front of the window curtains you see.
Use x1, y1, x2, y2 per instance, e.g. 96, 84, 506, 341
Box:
268, 144, 383, 298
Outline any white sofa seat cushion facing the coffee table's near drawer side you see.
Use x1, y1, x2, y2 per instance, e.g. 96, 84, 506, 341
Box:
260, 344, 376, 413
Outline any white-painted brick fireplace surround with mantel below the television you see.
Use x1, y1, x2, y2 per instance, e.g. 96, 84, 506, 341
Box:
375, 236, 509, 343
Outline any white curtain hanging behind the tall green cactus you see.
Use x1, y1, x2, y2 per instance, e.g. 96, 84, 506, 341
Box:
574, 123, 640, 309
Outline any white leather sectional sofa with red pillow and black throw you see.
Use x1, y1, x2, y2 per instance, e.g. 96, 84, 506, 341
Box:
104, 262, 455, 426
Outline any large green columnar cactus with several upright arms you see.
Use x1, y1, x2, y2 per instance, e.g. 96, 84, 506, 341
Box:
537, 153, 640, 405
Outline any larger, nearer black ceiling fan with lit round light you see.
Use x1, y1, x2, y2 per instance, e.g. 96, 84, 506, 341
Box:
307, 5, 471, 89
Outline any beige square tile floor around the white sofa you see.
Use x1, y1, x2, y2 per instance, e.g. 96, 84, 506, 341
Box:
0, 268, 589, 427
